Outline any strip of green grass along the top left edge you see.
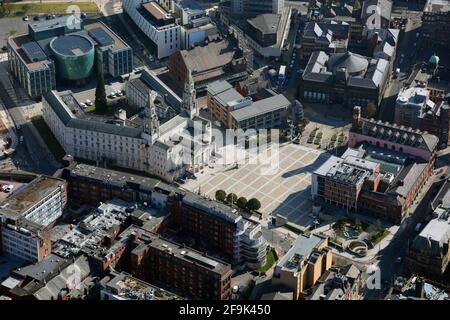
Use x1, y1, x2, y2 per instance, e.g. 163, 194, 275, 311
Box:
5, 2, 100, 15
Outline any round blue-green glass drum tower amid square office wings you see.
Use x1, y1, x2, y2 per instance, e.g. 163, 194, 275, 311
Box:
50, 34, 95, 80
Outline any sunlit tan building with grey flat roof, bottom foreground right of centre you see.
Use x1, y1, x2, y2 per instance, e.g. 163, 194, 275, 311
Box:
272, 234, 332, 300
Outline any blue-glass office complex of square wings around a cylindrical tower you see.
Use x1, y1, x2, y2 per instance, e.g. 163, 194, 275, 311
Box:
7, 16, 133, 98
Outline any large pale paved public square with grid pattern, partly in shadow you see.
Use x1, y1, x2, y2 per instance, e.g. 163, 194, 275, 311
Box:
183, 144, 330, 226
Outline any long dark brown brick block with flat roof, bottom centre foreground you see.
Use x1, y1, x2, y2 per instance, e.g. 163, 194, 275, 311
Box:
125, 227, 232, 300
